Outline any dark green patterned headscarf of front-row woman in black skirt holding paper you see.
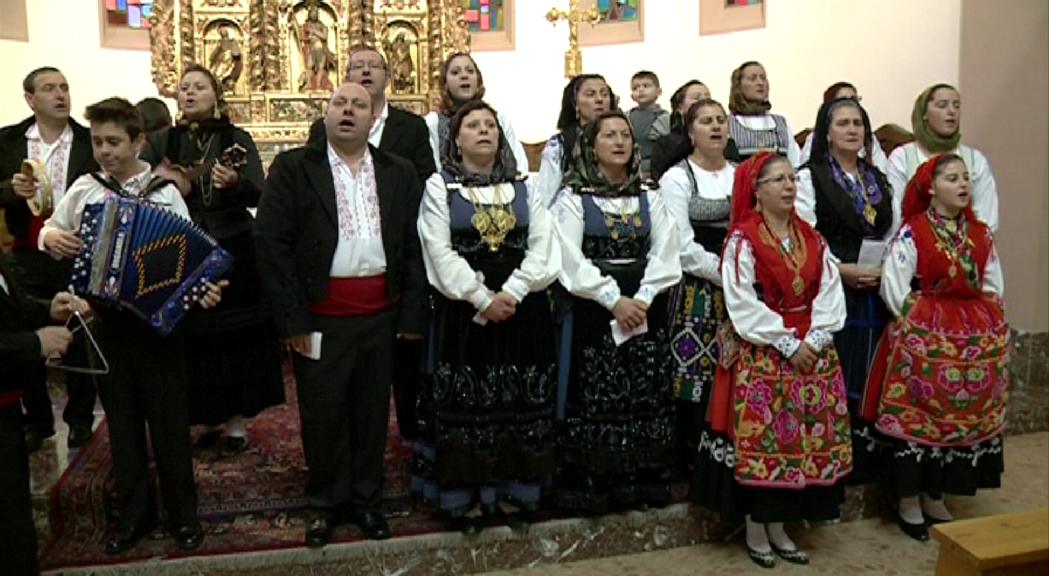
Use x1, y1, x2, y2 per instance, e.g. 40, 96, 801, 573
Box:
562, 110, 641, 198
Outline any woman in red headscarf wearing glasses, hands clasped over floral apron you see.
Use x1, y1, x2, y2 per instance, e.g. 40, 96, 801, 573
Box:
698, 152, 852, 568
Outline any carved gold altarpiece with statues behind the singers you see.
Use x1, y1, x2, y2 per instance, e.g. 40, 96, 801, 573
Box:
150, 0, 470, 155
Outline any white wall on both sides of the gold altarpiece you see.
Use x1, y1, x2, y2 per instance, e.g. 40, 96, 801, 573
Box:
0, 0, 960, 144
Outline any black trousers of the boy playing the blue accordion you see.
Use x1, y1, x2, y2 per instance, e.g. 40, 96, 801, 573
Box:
97, 310, 197, 529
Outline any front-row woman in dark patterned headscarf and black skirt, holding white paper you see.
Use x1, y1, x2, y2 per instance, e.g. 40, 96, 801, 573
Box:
553, 110, 681, 513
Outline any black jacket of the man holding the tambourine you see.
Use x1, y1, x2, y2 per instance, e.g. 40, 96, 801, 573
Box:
0, 116, 99, 240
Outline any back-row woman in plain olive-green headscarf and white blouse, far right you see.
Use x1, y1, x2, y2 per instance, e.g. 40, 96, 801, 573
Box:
887, 84, 998, 232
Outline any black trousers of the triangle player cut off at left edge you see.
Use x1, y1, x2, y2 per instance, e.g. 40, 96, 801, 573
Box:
0, 404, 40, 576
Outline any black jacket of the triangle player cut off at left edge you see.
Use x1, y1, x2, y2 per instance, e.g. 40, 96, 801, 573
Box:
0, 262, 50, 394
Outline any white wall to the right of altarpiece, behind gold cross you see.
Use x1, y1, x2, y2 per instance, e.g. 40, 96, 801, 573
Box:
474, 0, 961, 142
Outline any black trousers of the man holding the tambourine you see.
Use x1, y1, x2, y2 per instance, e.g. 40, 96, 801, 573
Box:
9, 250, 95, 434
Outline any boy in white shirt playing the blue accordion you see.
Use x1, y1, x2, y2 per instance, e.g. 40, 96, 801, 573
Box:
39, 98, 224, 554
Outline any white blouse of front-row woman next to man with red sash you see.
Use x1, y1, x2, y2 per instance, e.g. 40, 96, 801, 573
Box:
419, 174, 561, 311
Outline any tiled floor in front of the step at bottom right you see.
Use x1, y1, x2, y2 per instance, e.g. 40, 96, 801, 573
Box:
488, 432, 1049, 576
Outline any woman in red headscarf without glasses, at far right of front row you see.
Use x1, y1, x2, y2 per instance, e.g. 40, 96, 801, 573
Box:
862, 153, 1009, 540
